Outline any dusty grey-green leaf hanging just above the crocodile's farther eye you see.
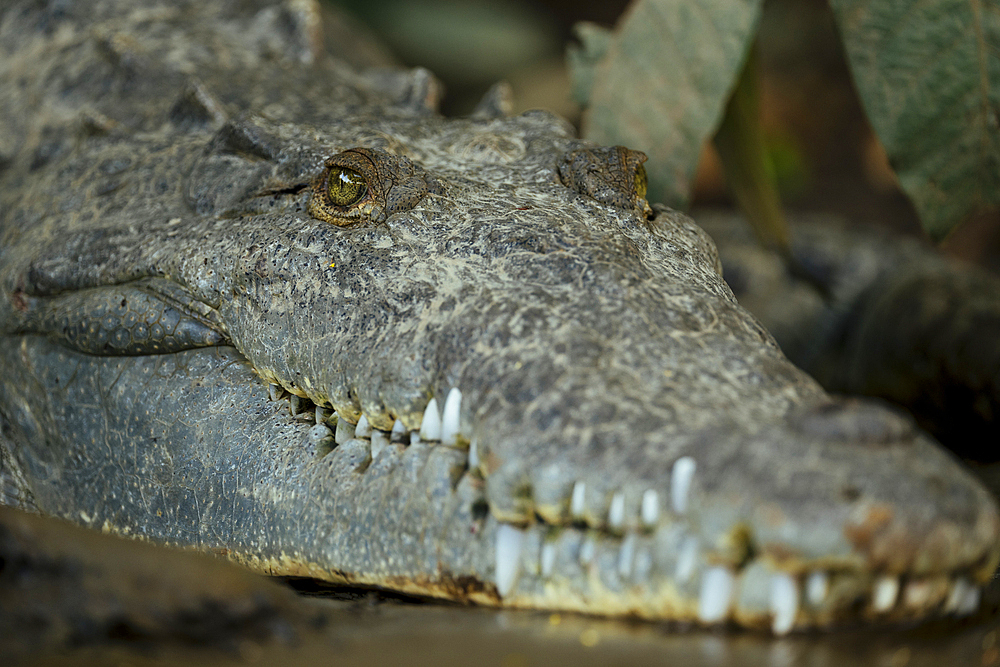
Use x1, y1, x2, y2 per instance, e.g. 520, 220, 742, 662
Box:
583, 0, 762, 206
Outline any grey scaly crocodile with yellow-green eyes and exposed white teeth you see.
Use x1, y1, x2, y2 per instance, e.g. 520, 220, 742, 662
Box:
0, 0, 1000, 634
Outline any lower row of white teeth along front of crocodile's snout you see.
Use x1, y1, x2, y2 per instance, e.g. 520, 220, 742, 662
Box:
496, 523, 981, 635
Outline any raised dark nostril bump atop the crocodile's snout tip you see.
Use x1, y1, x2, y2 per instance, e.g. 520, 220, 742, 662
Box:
792, 399, 917, 445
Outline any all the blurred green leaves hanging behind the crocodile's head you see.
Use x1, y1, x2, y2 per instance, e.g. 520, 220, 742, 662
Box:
568, 0, 1000, 245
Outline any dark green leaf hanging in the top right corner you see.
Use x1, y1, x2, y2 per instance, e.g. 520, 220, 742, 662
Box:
830, 0, 1000, 238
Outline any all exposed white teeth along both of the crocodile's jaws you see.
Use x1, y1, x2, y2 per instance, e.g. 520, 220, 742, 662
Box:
269, 384, 981, 635
